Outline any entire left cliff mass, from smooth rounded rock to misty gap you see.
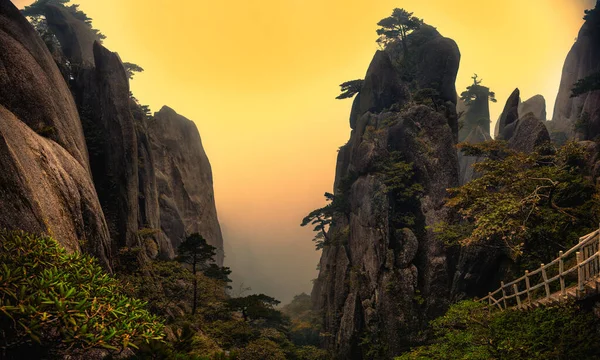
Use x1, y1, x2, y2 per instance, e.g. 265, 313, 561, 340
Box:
0, 0, 223, 267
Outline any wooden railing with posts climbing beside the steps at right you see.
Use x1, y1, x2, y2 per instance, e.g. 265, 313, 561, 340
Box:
479, 230, 600, 310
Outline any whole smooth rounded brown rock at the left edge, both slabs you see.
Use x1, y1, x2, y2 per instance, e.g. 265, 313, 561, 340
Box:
0, 0, 110, 268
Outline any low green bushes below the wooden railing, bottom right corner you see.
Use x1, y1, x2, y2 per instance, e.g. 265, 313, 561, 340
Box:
396, 301, 600, 360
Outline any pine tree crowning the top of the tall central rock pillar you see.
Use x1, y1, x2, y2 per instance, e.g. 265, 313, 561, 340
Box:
377, 8, 423, 53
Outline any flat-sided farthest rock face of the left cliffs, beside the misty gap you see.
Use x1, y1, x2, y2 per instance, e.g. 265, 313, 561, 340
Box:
148, 106, 223, 265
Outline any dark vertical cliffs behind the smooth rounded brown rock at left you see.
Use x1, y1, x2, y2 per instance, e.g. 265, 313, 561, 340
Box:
28, 0, 223, 265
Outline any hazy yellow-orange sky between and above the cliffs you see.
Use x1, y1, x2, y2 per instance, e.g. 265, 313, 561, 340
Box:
16, 0, 592, 300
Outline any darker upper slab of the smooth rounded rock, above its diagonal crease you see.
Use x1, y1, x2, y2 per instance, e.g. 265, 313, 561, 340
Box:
0, 0, 89, 169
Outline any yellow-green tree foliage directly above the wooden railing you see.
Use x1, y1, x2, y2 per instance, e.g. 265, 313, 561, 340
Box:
438, 141, 600, 268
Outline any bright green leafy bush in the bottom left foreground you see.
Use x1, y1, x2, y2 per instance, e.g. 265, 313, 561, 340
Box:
0, 230, 164, 358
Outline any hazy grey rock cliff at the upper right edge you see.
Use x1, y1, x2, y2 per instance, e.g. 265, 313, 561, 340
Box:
552, 4, 600, 139
